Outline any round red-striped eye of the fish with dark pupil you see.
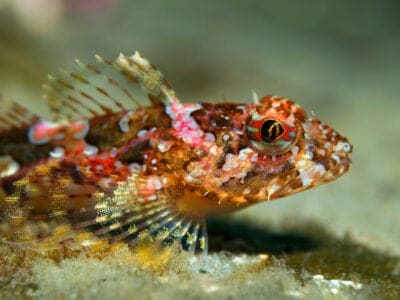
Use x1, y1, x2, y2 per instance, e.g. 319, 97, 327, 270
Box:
246, 116, 297, 155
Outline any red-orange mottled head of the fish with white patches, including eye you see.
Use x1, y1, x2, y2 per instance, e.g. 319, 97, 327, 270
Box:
189, 96, 352, 209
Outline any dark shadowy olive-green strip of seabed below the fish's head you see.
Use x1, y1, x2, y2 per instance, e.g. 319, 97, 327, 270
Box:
209, 218, 400, 299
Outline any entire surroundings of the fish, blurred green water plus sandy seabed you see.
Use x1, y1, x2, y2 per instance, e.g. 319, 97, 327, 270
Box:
0, 0, 400, 299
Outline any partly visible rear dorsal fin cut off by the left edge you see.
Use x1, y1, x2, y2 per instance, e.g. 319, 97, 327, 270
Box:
0, 95, 38, 134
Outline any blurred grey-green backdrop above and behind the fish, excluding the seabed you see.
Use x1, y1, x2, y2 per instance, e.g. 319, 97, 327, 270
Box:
0, 0, 400, 262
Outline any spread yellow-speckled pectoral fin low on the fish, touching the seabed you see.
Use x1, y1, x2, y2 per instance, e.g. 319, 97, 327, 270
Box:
0, 158, 207, 253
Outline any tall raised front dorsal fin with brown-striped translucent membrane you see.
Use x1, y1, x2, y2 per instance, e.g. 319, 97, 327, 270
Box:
44, 51, 178, 121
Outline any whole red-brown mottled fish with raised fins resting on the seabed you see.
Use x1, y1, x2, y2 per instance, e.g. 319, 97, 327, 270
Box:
0, 52, 352, 252
